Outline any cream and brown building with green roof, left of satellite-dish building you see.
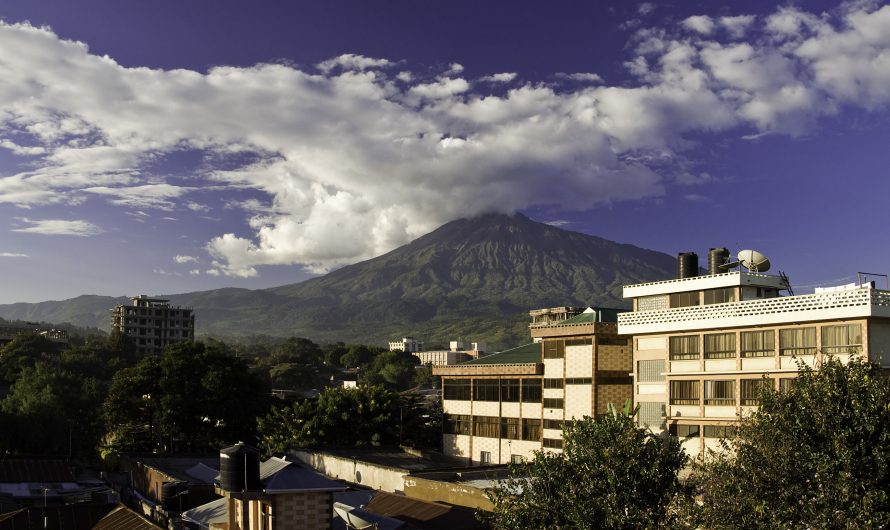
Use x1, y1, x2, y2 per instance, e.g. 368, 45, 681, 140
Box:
433, 308, 633, 464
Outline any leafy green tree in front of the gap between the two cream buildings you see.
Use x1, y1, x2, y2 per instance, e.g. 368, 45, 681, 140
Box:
483, 409, 686, 529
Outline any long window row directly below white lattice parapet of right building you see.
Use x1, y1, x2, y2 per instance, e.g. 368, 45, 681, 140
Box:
668, 324, 862, 361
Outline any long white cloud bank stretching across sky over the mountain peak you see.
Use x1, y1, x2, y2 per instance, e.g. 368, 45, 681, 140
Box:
0, 2, 890, 276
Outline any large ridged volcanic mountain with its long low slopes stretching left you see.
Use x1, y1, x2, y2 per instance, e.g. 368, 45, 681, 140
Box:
0, 214, 676, 347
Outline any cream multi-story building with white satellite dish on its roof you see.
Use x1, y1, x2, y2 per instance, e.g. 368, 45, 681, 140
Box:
618, 253, 890, 457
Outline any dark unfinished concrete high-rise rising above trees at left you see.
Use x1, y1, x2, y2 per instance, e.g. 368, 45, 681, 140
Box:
112, 294, 195, 355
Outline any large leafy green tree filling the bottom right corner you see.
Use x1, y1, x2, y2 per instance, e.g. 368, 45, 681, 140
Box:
691, 359, 890, 529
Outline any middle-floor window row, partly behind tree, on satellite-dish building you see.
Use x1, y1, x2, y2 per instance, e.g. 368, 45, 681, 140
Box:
670, 378, 794, 406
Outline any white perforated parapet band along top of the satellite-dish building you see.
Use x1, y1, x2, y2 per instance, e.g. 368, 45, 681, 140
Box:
618, 288, 890, 335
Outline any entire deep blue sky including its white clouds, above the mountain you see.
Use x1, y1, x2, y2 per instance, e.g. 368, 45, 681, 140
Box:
0, 0, 890, 303
